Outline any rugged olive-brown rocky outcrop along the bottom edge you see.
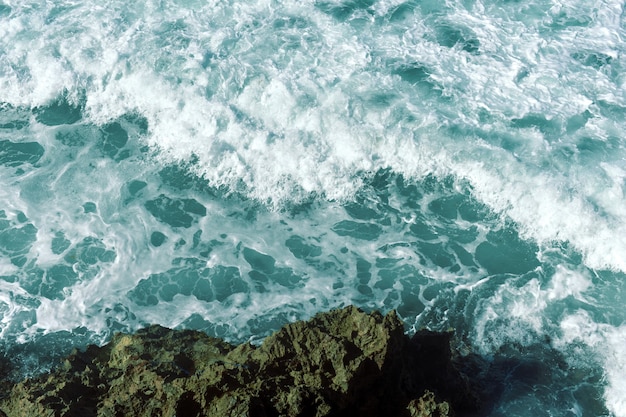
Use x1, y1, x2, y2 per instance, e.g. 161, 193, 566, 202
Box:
0, 307, 476, 417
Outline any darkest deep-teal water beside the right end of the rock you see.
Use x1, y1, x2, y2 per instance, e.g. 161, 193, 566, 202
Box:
416, 284, 609, 417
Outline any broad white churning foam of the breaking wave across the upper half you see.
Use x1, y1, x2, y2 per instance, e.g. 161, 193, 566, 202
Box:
0, 1, 626, 270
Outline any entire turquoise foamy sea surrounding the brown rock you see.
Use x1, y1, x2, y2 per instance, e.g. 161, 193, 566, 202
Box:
0, 0, 626, 417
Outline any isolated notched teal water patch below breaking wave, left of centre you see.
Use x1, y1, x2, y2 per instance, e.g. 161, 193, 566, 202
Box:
145, 194, 206, 228
